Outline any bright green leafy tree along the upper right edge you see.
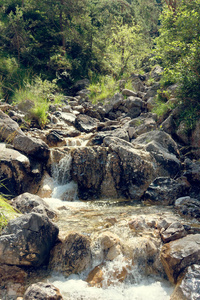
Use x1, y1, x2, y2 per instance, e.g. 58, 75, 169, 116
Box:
156, 0, 200, 129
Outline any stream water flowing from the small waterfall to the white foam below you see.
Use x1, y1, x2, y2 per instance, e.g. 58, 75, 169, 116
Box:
41, 151, 178, 300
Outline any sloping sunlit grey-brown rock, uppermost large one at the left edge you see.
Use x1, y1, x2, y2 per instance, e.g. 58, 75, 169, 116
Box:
0, 110, 24, 143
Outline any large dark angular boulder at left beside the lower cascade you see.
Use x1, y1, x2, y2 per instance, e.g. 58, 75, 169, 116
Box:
0, 213, 58, 266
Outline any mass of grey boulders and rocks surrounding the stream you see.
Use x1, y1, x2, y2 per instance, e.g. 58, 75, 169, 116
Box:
0, 71, 200, 299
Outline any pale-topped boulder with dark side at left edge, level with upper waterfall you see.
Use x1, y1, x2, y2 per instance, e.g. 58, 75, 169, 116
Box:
0, 144, 40, 196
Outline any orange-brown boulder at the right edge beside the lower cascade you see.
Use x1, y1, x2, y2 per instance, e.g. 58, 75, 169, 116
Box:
160, 234, 200, 283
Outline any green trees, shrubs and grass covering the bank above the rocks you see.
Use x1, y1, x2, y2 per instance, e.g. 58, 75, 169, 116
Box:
0, 0, 200, 129
